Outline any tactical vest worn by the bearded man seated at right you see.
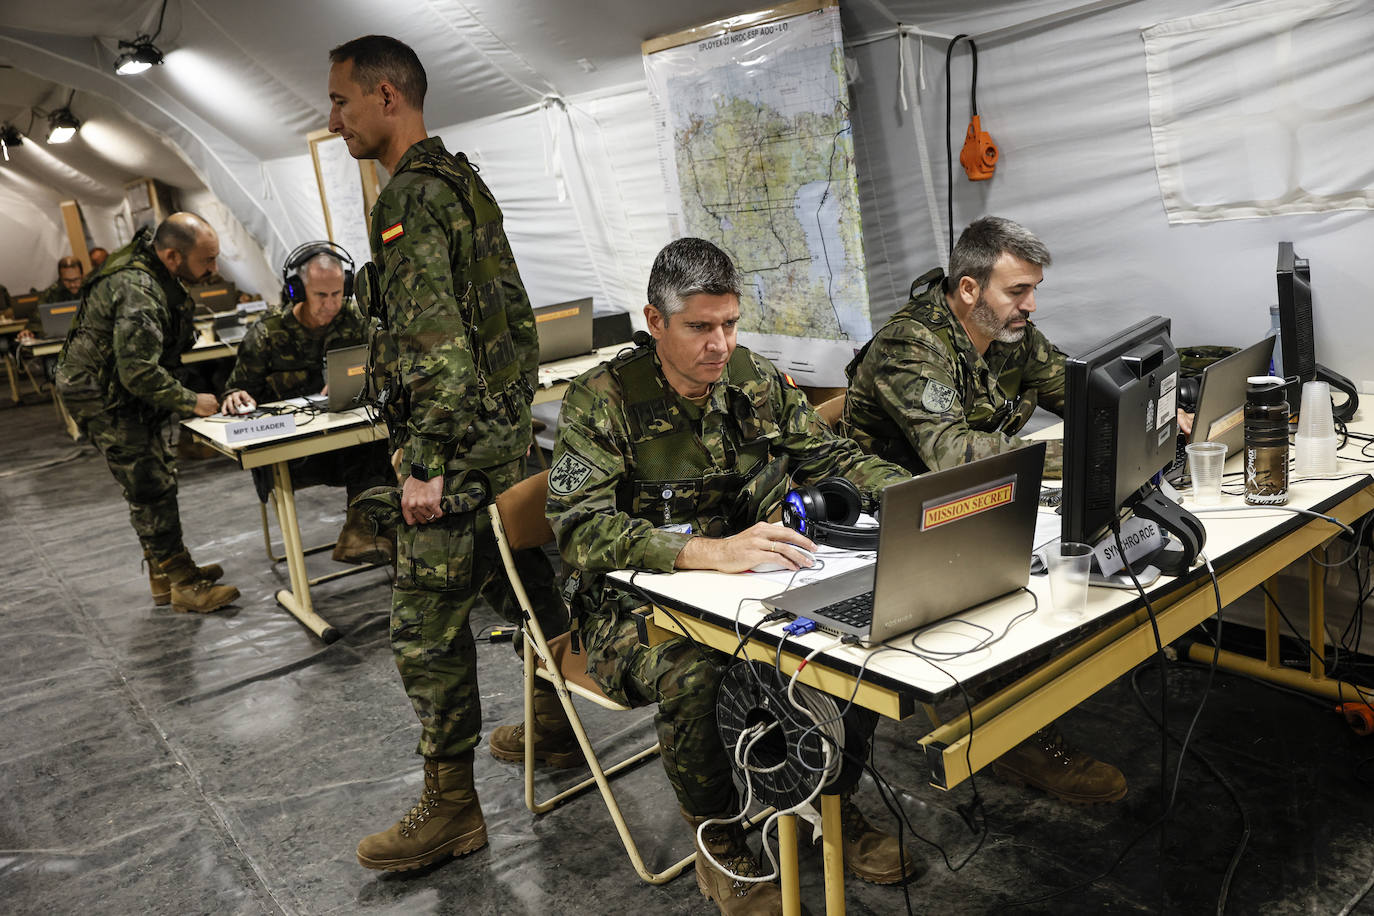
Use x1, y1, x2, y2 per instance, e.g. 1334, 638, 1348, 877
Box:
845, 268, 1039, 468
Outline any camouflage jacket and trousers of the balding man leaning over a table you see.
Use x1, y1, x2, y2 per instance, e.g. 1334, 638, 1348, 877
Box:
56, 229, 195, 563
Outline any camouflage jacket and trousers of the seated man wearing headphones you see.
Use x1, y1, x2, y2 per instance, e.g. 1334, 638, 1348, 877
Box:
221, 301, 396, 500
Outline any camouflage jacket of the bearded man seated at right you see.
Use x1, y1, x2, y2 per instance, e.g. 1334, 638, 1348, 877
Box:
840, 271, 1065, 474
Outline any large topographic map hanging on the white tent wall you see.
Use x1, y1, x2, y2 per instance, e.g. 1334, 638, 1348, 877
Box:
644, 3, 872, 386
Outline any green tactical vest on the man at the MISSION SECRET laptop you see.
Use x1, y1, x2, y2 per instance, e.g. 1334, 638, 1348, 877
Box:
609, 346, 787, 537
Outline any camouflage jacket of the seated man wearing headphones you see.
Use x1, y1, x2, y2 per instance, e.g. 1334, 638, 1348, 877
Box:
224, 301, 367, 401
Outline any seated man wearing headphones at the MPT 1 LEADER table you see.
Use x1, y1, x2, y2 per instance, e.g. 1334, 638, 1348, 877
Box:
220, 246, 396, 563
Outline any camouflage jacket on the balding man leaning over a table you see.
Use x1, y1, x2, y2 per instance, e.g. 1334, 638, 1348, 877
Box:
56, 229, 195, 416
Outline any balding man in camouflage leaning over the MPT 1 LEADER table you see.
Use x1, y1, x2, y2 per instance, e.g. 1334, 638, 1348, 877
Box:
56, 213, 239, 614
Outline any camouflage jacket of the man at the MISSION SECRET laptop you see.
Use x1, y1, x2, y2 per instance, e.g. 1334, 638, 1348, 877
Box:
547, 347, 910, 575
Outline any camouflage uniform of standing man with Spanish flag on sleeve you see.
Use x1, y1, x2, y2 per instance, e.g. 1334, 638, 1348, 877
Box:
359, 137, 567, 757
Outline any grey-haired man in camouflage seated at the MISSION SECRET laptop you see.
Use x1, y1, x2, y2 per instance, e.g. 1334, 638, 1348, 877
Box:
548, 239, 916, 913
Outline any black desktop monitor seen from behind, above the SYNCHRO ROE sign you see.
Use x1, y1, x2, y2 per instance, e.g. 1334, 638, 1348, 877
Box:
1062, 317, 1179, 544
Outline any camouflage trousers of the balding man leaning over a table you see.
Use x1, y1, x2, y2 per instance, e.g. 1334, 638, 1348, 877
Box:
82, 409, 185, 563
